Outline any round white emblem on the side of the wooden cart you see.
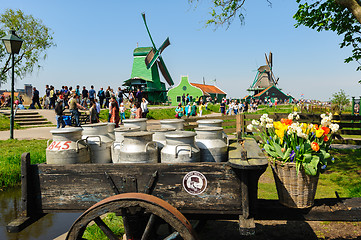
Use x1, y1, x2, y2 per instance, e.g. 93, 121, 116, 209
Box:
183, 171, 207, 195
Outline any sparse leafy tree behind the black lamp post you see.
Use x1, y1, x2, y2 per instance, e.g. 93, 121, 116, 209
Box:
0, 9, 56, 84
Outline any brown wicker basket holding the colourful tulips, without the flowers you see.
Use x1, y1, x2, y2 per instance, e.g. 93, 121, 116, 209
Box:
271, 161, 319, 208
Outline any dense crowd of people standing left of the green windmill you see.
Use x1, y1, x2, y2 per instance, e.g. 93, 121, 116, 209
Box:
23, 85, 149, 128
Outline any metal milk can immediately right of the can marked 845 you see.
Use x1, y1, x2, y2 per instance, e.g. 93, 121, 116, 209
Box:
82, 123, 113, 163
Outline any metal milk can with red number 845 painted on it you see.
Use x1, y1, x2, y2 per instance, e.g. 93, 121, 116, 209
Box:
46, 128, 90, 164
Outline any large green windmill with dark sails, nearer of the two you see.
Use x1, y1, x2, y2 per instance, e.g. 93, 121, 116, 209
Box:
123, 13, 174, 103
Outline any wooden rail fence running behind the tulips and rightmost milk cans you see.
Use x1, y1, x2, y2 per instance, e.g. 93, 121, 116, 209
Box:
184, 113, 361, 145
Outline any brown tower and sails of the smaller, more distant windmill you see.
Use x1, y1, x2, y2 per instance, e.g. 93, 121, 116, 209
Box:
247, 52, 279, 95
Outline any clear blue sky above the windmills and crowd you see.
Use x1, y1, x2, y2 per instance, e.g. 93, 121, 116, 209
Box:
0, 0, 361, 100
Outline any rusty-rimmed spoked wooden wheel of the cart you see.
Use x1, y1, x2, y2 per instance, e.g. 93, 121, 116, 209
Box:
66, 193, 197, 240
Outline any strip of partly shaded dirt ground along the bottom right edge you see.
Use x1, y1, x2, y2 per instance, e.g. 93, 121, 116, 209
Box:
198, 221, 361, 240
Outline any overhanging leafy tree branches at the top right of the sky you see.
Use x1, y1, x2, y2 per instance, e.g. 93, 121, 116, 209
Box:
188, 0, 361, 70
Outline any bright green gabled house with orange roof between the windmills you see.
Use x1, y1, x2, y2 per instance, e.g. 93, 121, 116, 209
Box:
167, 76, 227, 106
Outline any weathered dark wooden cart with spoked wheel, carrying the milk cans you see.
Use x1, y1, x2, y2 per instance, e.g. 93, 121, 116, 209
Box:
7, 139, 361, 239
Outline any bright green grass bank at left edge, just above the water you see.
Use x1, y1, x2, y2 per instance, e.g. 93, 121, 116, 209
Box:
0, 140, 47, 189
